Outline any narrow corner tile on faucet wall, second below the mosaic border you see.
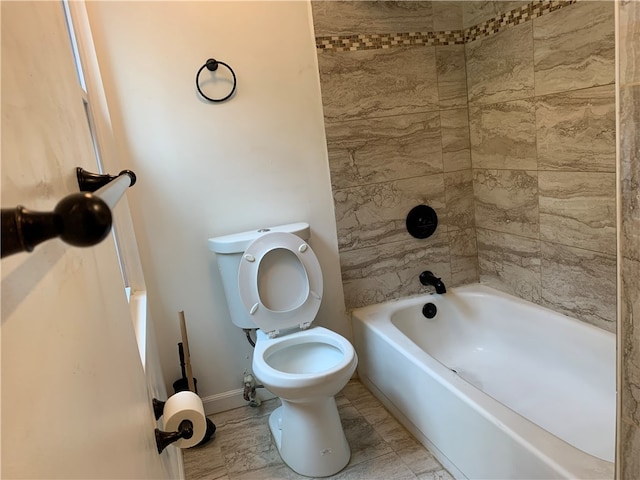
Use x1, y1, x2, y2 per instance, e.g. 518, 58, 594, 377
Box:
440, 108, 471, 172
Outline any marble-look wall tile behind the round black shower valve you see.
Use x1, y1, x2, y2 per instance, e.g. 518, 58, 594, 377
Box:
334, 174, 447, 251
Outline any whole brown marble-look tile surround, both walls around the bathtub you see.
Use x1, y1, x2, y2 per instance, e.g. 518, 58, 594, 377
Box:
313, 1, 616, 331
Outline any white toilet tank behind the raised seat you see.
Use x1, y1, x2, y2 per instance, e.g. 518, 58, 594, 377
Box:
208, 222, 311, 328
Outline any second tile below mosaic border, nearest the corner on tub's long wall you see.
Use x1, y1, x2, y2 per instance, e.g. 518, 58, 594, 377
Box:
469, 99, 537, 170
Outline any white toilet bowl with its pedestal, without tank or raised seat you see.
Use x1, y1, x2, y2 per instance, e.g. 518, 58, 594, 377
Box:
253, 327, 358, 477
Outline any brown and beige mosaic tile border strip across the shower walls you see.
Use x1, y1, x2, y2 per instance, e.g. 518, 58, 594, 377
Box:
316, 0, 577, 52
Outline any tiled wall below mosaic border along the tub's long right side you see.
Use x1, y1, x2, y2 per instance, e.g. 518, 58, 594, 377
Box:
465, 1, 616, 331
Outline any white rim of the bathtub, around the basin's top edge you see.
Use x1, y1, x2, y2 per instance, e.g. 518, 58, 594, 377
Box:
351, 283, 614, 478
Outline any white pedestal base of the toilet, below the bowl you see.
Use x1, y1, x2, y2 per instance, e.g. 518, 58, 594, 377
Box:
269, 397, 351, 477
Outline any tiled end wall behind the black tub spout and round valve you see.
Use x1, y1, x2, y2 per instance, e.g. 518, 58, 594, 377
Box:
312, 1, 478, 308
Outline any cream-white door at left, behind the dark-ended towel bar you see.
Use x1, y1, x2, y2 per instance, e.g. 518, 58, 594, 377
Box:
0, 2, 175, 479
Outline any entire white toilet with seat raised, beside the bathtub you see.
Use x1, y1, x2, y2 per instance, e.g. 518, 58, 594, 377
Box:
209, 223, 358, 477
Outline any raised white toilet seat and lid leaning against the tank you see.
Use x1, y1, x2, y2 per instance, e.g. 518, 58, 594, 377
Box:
238, 232, 323, 336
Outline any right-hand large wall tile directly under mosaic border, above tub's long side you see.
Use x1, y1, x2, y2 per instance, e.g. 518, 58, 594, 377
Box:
533, 1, 615, 95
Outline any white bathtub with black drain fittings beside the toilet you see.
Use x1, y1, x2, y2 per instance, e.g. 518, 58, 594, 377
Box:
353, 285, 616, 480
